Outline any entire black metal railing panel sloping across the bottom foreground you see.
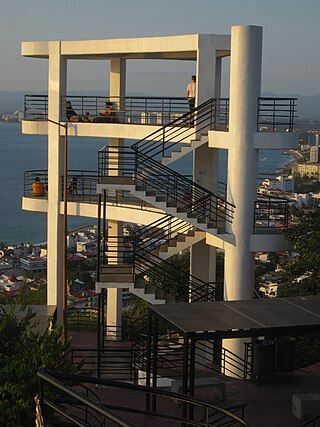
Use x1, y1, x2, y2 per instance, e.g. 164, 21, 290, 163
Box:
38, 371, 247, 427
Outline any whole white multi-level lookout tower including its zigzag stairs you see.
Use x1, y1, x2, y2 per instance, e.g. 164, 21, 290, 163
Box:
22, 26, 298, 422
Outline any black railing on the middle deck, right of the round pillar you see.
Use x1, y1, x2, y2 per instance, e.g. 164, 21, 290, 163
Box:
253, 194, 292, 234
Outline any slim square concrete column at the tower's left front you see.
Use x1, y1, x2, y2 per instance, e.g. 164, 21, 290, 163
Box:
47, 42, 67, 321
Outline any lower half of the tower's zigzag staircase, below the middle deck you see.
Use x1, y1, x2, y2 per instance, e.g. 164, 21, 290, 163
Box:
98, 215, 220, 304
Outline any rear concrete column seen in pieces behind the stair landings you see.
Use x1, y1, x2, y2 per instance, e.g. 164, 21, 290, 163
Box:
107, 58, 126, 339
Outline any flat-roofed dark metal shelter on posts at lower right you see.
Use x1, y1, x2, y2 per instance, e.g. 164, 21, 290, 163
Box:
147, 296, 320, 395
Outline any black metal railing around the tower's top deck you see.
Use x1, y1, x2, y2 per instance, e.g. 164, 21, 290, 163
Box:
24, 95, 297, 132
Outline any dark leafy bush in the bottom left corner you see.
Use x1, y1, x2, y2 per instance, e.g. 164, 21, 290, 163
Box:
0, 306, 72, 427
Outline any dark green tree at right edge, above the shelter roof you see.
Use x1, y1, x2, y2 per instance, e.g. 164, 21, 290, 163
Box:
279, 207, 320, 296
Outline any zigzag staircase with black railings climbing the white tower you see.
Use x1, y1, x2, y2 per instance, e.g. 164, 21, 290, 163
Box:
97, 99, 234, 304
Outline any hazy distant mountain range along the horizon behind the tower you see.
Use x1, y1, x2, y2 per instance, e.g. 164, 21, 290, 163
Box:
0, 91, 320, 118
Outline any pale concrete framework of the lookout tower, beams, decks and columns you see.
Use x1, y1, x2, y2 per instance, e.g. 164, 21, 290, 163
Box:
22, 26, 298, 368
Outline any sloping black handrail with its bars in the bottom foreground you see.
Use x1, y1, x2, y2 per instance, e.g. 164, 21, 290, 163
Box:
38, 371, 248, 427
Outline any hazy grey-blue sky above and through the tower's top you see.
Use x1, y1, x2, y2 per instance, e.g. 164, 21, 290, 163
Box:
0, 0, 320, 96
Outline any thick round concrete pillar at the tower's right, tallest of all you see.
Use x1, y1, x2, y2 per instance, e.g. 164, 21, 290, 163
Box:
224, 26, 262, 374
